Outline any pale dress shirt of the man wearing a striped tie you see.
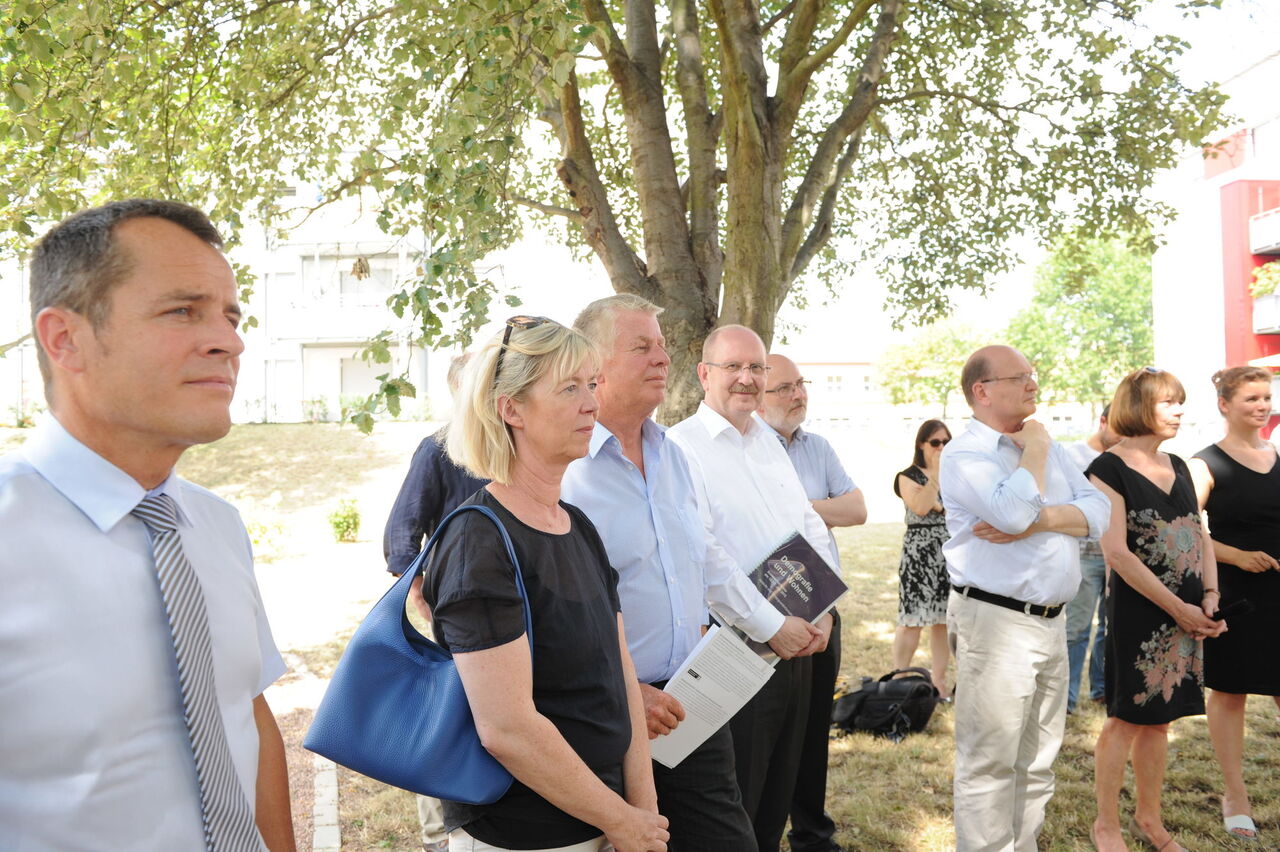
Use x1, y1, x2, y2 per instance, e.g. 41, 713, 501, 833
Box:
0, 420, 284, 852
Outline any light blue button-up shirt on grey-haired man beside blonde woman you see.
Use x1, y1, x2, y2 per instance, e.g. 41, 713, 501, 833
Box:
561, 420, 782, 683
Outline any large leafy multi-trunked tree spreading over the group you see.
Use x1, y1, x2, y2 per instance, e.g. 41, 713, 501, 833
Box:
0, 0, 1224, 414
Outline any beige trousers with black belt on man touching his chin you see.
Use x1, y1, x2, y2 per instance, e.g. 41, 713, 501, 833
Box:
947, 592, 1068, 852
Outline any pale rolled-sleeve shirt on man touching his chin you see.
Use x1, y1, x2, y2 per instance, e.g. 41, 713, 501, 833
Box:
938, 420, 1111, 606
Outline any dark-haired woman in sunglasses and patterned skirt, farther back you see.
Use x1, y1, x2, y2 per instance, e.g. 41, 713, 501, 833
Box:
893, 420, 951, 697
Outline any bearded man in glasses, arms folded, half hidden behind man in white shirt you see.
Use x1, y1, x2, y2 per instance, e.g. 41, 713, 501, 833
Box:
759, 353, 867, 852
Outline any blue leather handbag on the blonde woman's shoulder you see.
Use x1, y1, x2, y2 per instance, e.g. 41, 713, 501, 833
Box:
302, 505, 534, 805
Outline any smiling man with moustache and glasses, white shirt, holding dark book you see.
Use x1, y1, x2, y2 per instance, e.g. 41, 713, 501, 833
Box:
667, 325, 836, 852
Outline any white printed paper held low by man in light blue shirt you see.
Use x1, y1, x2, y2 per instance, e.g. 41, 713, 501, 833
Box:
649, 624, 773, 769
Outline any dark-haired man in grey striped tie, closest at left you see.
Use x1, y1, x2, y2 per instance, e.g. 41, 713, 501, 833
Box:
0, 201, 294, 852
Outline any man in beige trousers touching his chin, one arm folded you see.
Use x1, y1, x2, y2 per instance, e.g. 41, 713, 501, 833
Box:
938, 345, 1110, 852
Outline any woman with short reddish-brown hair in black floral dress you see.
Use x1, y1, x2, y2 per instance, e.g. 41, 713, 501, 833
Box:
1087, 367, 1224, 852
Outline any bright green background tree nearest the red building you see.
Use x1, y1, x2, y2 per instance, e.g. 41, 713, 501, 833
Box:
1006, 235, 1155, 408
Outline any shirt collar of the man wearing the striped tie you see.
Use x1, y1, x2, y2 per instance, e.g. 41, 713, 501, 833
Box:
22, 417, 191, 532
